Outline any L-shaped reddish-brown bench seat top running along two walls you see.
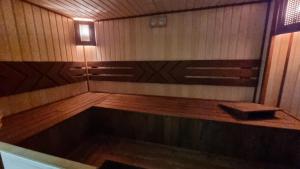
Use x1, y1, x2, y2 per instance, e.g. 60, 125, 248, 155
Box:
0, 93, 300, 144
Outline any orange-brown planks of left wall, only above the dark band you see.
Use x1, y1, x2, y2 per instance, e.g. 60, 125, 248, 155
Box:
0, 0, 84, 61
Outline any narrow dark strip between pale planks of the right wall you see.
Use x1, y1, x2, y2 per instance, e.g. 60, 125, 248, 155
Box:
277, 33, 294, 107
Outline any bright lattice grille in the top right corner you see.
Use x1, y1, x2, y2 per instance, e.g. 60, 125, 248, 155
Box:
284, 0, 300, 26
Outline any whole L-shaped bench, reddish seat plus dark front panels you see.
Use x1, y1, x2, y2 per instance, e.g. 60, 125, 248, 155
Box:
7, 93, 300, 168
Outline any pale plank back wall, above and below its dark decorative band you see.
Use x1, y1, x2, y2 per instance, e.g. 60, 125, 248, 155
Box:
85, 3, 268, 101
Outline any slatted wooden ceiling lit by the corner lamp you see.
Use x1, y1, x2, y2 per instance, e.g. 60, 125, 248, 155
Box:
24, 0, 266, 20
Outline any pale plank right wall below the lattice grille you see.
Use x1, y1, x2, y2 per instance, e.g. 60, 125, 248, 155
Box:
264, 32, 300, 117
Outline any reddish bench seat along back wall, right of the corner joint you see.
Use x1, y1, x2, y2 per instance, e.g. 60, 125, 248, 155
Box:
94, 94, 300, 130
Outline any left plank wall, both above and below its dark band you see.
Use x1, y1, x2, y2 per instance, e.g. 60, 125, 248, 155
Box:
0, 0, 87, 116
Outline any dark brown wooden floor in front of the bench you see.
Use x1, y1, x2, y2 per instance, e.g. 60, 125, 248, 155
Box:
68, 136, 292, 169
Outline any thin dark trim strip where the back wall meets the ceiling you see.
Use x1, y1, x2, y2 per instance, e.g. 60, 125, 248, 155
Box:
97, 0, 271, 22
